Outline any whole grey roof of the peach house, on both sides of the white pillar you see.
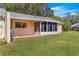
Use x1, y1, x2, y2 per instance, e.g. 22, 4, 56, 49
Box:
0, 8, 61, 23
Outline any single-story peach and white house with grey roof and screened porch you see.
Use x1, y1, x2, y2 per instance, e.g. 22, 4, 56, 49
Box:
0, 9, 62, 43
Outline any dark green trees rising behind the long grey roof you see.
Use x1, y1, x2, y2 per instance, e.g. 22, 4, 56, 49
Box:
6, 3, 53, 17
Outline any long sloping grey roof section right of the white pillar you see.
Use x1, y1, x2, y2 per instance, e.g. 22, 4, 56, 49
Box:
11, 12, 59, 22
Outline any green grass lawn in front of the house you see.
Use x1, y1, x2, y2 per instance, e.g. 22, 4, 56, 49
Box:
0, 31, 79, 56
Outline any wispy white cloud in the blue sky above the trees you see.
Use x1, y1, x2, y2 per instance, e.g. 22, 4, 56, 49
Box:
51, 6, 77, 17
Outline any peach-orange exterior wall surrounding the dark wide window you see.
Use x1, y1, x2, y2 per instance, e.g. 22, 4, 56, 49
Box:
11, 19, 34, 36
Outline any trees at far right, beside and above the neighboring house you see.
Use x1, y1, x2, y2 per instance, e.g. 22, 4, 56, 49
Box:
63, 12, 79, 30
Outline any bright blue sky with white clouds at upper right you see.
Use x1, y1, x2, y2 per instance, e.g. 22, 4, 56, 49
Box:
48, 3, 79, 17
